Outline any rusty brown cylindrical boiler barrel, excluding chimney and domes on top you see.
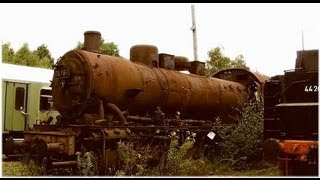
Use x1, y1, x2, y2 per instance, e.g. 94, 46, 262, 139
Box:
52, 51, 247, 119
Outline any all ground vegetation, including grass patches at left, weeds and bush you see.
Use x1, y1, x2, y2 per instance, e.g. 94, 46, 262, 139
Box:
3, 102, 280, 176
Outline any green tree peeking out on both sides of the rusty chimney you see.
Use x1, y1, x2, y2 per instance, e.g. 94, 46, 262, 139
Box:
75, 38, 121, 57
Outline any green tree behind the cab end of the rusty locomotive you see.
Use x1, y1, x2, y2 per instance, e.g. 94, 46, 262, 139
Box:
206, 47, 249, 75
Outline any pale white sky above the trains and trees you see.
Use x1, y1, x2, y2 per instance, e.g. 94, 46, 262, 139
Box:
0, 3, 320, 76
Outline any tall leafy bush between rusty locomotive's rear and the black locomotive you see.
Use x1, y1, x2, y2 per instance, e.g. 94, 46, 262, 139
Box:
211, 102, 263, 168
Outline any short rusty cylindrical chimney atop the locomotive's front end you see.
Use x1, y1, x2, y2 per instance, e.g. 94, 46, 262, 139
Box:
84, 31, 101, 52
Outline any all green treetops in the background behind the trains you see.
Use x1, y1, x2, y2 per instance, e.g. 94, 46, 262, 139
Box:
2, 38, 249, 76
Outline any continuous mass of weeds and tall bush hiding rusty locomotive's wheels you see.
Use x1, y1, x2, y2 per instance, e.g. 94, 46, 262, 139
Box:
117, 102, 263, 176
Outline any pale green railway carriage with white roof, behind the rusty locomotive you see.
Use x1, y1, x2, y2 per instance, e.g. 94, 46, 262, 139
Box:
0, 63, 58, 140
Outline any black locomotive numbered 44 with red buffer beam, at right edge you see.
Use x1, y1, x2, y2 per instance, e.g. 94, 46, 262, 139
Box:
264, 50, 319, 175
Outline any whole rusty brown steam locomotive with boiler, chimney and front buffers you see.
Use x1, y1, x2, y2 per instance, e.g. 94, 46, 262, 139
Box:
6, 31, 263, 174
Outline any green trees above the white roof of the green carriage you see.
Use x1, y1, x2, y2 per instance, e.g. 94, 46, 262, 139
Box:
2, 43, 54, 69
